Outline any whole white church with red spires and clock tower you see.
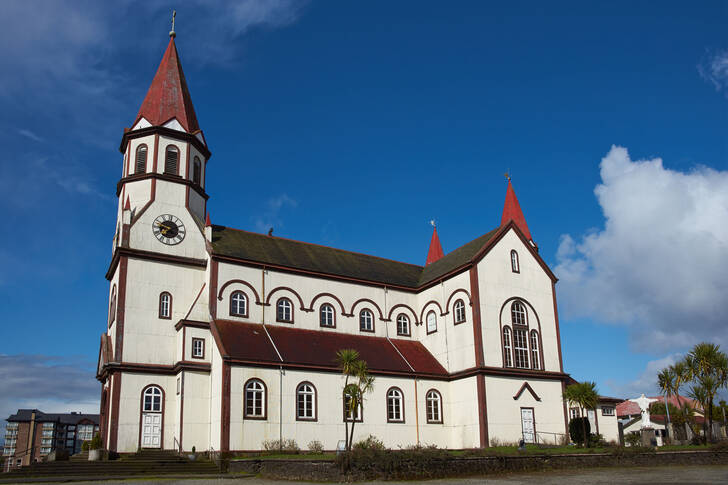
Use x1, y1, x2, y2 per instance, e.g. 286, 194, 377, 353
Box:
97, 32, 569, 453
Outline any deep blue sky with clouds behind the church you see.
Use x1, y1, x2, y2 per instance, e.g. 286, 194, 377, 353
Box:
0, 0, 728, 422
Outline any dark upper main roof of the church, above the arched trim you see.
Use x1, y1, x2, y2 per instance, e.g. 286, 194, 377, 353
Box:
212, 225, 498, 289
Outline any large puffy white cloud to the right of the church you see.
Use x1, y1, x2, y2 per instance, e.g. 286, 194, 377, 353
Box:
555, 146, 728, 352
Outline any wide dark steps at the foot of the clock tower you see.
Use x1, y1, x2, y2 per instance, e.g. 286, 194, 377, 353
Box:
0, 450, 220, 483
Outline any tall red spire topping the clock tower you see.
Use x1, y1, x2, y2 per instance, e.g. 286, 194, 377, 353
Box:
134, 35, 200, 133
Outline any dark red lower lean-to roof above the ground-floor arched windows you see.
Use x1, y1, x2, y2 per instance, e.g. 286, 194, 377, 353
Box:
215, 320, 447, 376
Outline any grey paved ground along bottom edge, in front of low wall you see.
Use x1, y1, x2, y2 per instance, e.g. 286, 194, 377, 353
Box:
15, 465, 728, 485
